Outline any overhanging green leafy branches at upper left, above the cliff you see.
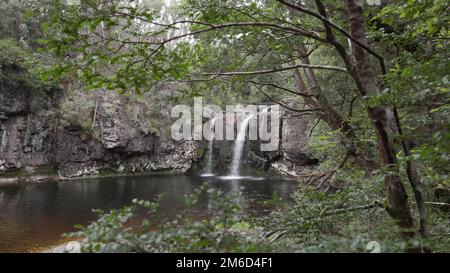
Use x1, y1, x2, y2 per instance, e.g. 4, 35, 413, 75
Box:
41, 1, 199, 94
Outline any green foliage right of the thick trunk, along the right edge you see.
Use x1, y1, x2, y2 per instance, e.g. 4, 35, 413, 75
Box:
369, 0, 450, 188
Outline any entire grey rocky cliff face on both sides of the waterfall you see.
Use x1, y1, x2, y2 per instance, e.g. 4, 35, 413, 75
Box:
0, 78, 317, 180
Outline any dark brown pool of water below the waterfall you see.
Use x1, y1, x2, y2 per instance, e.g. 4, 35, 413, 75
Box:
0, 173, 296, 252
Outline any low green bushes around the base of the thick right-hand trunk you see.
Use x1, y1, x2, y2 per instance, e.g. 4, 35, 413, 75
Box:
261, 169, 449, 253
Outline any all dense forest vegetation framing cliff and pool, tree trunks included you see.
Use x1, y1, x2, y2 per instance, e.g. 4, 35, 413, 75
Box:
0, 0, 450, 252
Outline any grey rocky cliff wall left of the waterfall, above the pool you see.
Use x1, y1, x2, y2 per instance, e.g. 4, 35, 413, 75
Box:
0, 79, 198, 180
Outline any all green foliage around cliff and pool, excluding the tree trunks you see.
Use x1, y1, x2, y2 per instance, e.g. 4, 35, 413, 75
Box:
9, 0, 450, 252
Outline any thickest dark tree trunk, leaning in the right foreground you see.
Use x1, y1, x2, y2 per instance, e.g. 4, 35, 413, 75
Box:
345, 0, 415, 242
